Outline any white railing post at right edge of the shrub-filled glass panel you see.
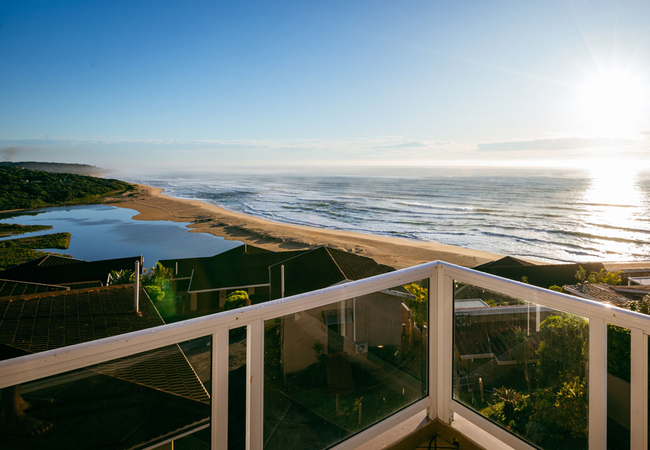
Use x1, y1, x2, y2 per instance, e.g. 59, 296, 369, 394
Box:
589, 318, 607, 450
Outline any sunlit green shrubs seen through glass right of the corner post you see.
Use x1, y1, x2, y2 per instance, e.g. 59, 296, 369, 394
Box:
470, 314, 588, 449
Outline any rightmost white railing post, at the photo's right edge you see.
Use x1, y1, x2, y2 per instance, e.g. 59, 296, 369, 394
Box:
630, 328, 648, 448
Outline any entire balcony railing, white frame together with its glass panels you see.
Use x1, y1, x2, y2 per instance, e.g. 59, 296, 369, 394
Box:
0, 262, 650, 449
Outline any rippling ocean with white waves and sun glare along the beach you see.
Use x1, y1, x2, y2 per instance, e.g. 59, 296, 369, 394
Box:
129, 167, 650, 262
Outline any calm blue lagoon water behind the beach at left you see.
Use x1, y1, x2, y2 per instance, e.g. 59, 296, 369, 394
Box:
0, 205, 241, 267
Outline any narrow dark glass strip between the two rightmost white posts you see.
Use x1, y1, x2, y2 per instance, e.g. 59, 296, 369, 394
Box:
607, 325, 632, 450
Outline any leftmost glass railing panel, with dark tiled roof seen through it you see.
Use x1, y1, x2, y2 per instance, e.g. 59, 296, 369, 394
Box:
0, 336, 212, 450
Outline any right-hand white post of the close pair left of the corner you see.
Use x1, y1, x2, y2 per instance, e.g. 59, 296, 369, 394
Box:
246, 319, 264, 450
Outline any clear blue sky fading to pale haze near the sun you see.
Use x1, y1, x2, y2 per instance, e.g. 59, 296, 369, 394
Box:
0, 0, 650, 171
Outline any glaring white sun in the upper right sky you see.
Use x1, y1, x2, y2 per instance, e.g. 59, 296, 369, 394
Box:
580, 69, 650, 134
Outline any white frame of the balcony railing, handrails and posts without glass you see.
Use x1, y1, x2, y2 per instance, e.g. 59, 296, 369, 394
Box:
0, 261, 650, 448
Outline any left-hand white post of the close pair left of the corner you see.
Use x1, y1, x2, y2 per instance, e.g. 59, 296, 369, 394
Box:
210, 328, 230, 450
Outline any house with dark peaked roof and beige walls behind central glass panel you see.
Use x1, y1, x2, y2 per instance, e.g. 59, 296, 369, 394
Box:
269, 247, 413, 375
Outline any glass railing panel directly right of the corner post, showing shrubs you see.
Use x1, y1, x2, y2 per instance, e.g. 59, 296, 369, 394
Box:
453, 283, 589, 449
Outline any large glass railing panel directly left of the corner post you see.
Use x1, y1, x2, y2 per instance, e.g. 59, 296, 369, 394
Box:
264, 281, 429, 450
